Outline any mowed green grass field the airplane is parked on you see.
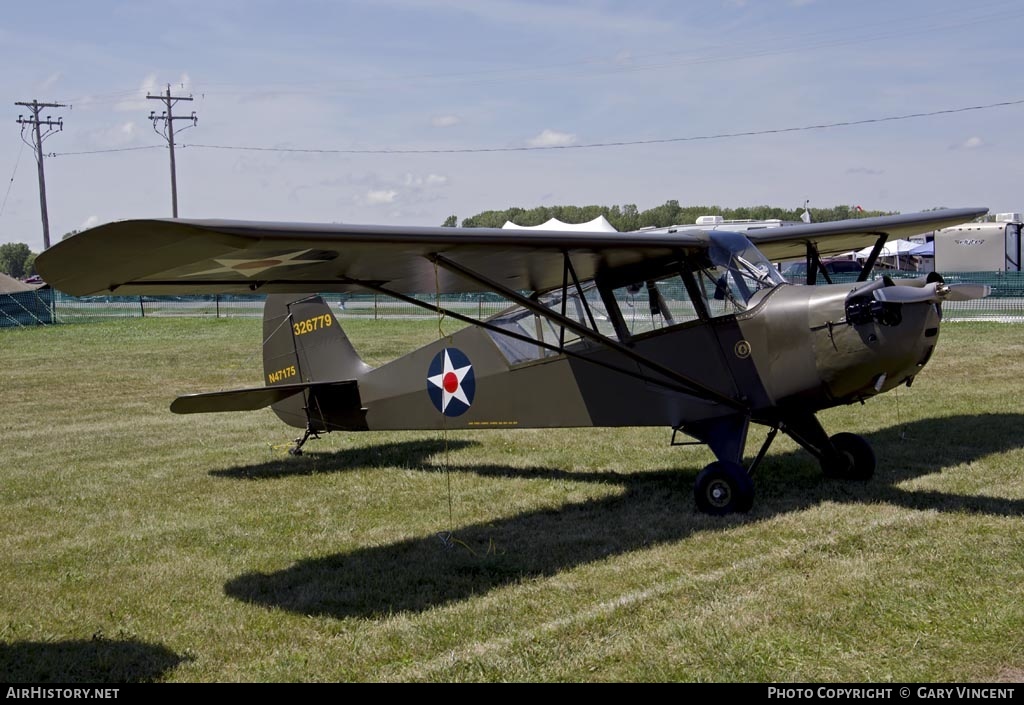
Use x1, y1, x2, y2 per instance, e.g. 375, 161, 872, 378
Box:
0, 319, 1024, 682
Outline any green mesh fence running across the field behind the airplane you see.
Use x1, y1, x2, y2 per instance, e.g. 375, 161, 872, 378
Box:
0, 272, 1024, 328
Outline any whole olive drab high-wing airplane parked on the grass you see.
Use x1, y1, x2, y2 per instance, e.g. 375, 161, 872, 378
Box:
36, 203, 988, 514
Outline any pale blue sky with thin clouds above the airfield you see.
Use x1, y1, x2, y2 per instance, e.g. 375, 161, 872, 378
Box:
0, 0, 1024, 252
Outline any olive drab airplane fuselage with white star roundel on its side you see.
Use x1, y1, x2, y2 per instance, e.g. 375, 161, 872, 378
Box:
348, 284, 939, 429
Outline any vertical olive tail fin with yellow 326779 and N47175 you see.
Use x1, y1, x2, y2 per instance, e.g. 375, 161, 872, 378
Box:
263, 294, 372, 431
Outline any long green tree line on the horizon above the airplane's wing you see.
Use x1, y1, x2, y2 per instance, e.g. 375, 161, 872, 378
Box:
441, 200, 895, 233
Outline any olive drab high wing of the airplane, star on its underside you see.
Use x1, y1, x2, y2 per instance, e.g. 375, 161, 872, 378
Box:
36, 208, 987, 296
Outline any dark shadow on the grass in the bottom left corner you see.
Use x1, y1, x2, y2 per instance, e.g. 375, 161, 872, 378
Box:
0, 638, 186, 685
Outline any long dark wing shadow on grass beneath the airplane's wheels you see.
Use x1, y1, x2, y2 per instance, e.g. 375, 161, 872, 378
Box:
224, 414, 1024, 618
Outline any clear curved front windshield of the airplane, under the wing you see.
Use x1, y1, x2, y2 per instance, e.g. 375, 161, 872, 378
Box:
697, 231, 785, 316
